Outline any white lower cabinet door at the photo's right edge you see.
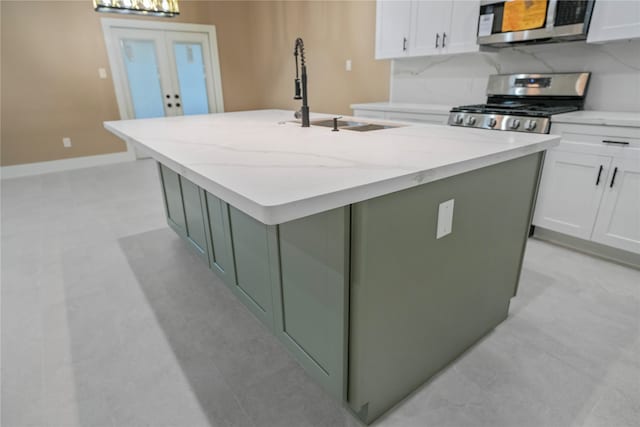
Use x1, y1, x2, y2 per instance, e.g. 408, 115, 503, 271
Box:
592, 157, 640, 253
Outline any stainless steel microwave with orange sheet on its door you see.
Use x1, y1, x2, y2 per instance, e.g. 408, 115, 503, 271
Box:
478, 0, 595, 47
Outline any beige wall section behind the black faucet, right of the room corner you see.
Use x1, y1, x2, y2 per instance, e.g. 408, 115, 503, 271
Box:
251, 1, 389, 114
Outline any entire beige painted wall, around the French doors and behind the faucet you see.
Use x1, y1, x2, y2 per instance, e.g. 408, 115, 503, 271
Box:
0, 0, 389, 166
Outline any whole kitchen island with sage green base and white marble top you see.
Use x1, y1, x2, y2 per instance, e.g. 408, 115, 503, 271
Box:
105, 110, 558, 423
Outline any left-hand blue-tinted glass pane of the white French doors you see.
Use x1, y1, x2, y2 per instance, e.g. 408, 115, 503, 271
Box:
120, 39, 165, 119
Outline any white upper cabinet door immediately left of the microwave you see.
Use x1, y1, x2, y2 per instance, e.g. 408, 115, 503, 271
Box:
442, 0, 480, 53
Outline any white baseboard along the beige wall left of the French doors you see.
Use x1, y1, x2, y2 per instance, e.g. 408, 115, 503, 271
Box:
0, 151, 136, 179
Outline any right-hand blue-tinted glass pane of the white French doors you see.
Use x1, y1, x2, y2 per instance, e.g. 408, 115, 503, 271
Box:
173, 42, 209, 115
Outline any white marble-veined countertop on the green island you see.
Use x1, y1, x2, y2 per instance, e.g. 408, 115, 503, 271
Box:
105, 110, 559, 224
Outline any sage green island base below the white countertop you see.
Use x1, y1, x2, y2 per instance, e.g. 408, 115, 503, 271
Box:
160, 153, 542, 423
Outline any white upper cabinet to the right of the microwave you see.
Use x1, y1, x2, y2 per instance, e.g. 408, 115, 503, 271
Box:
587, 0, 640, 43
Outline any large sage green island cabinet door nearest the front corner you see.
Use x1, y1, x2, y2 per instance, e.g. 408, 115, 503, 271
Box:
273, 206, 350, 400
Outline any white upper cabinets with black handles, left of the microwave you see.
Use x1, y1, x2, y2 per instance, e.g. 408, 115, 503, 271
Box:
376, 0, 480, 59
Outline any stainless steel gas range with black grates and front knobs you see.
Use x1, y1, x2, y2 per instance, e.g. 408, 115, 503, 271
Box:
449, 73, 591, 133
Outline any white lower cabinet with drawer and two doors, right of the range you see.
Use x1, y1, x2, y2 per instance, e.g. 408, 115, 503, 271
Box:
533, 126, 640, 253
